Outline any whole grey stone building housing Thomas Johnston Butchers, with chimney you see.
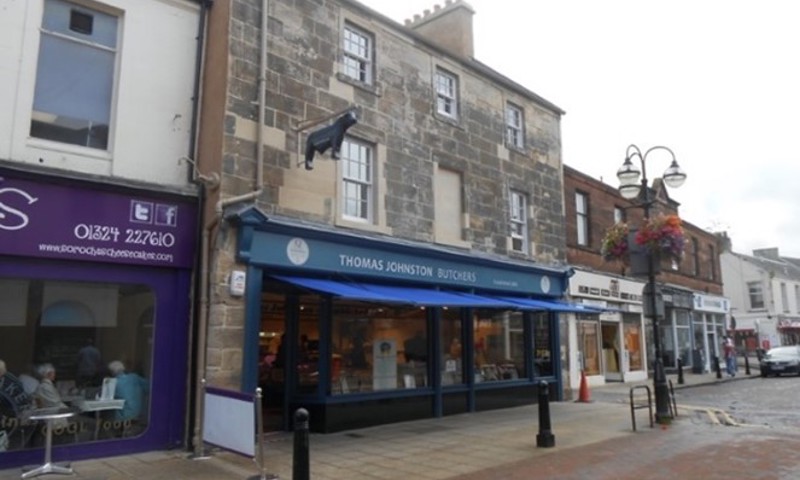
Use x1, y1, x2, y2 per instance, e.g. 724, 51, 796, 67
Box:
191, 0, 585, 431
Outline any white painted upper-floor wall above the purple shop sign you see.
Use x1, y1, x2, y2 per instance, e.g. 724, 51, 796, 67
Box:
0, 0, 200, 187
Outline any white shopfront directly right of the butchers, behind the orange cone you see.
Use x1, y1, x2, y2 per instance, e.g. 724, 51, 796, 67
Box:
569, 269, 647, 390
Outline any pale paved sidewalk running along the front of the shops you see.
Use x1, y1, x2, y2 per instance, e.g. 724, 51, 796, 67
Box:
0, 372, 757, 480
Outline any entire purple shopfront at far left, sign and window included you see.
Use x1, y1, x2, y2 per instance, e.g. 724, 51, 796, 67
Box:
0, 168, 197, 469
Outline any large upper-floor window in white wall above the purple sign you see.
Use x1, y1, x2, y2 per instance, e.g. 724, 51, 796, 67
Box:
30, 0, 118, 150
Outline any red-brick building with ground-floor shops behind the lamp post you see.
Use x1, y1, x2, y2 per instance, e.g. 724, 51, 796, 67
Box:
562, 165, 729, 388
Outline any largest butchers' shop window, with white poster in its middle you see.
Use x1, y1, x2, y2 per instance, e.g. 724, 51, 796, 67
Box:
331, 299, 430, 395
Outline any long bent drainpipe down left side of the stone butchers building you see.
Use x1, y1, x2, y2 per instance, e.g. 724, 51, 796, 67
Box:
194, 0, 269, 458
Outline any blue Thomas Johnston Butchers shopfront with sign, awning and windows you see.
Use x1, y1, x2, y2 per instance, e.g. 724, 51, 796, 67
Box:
231, 208, 591, 432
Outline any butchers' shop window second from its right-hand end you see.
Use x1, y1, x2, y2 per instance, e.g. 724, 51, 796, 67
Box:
473, 310, 527, 383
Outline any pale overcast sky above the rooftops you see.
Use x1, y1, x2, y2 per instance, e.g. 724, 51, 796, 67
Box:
360, 0, 800, 258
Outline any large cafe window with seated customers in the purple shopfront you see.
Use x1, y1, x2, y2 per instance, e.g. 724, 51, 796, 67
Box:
0, 278, 155, 450
